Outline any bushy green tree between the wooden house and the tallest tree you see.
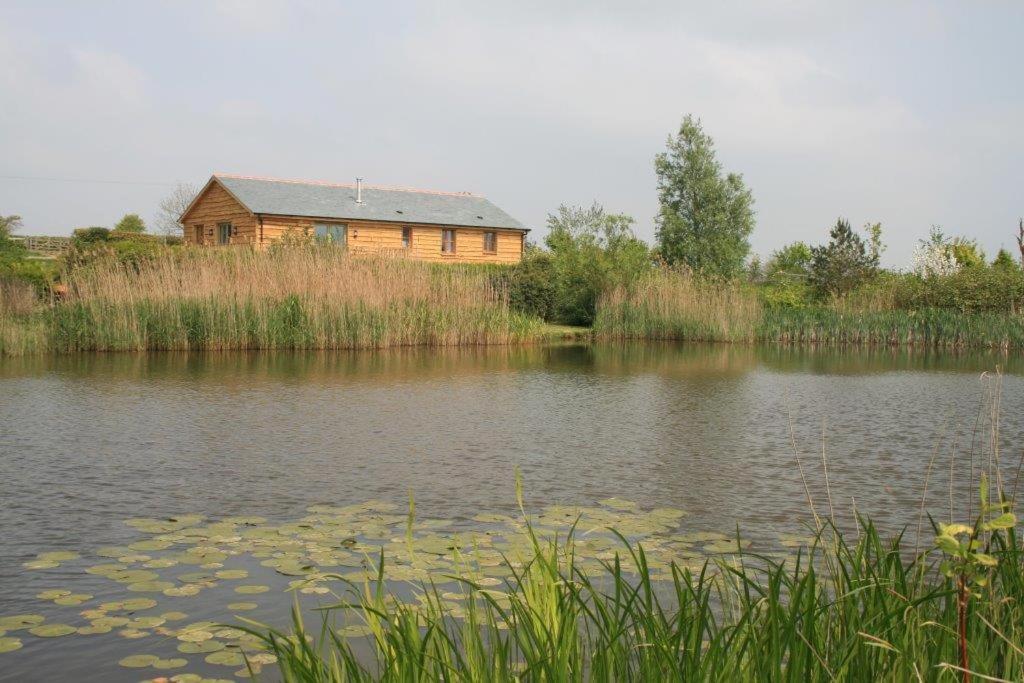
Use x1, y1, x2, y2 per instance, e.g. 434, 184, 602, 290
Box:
545, 203, 651, 325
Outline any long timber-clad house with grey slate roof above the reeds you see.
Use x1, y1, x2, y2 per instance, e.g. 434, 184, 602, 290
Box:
180, 173, 528, 263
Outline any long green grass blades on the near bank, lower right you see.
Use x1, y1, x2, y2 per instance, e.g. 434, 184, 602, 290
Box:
252, 501, 1024, 682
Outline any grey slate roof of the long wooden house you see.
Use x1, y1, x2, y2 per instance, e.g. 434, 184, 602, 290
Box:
213, 173, 526, 230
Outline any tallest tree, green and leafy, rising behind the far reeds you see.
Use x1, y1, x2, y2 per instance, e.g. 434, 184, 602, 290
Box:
654, 115, 754, 276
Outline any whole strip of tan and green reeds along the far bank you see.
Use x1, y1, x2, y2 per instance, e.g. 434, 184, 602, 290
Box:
0, 246, 1024, 355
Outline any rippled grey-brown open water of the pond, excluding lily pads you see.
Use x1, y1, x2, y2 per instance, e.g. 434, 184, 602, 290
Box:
0, 343, 1024, 681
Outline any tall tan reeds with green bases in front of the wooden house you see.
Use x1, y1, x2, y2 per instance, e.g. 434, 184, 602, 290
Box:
4, 246, 540, 352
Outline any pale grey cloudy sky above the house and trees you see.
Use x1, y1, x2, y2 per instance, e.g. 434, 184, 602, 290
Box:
0, 0, 1024, 267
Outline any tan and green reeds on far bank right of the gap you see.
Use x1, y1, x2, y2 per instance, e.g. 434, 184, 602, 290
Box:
594, 271, 1024, 349
